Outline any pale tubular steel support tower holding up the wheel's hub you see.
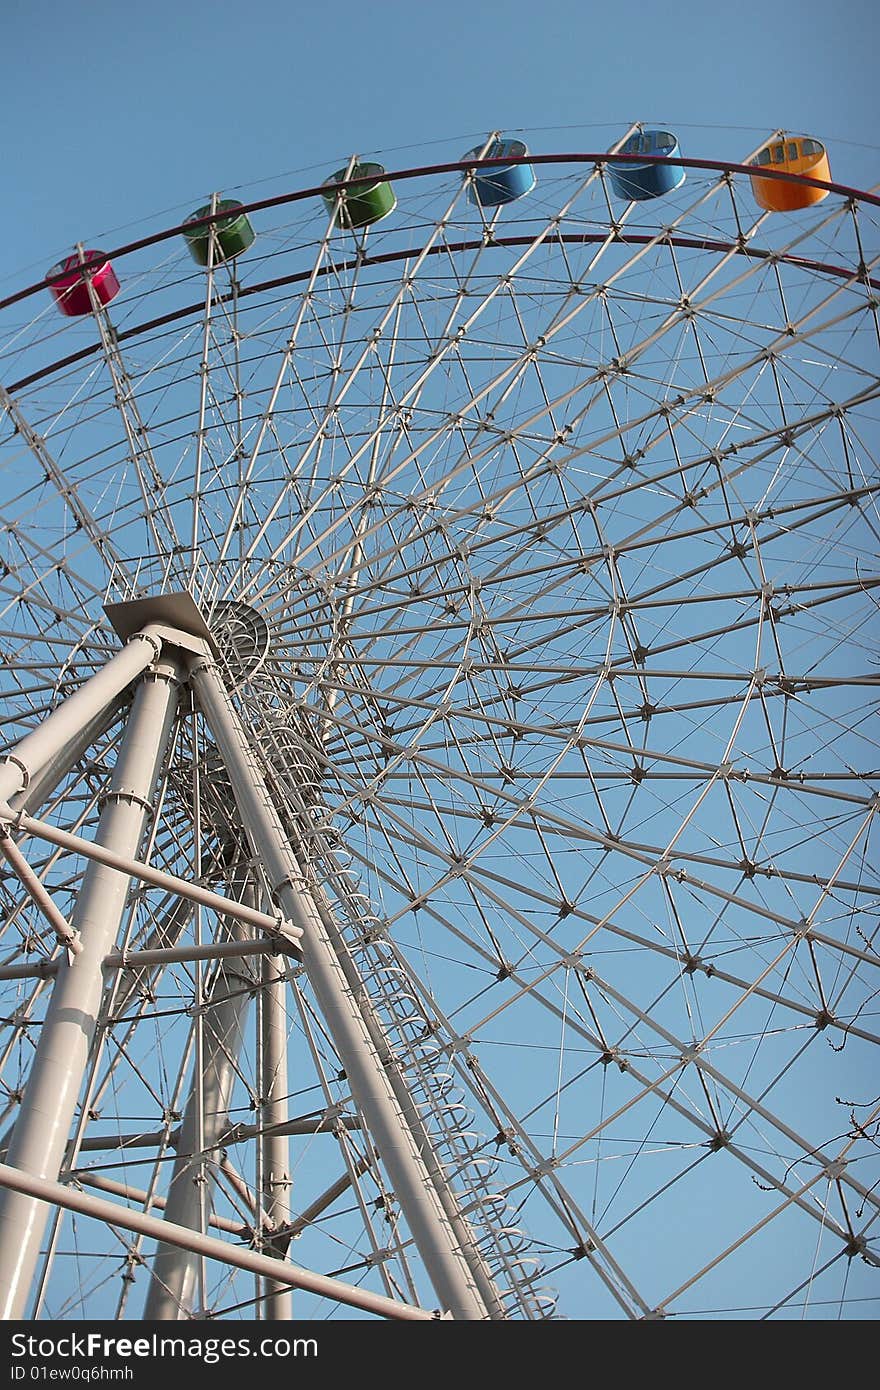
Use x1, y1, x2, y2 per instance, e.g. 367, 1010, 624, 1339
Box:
0, 600, 503, 1321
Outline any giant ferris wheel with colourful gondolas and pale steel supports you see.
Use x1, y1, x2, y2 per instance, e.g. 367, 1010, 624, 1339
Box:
0, 125, 880, 1321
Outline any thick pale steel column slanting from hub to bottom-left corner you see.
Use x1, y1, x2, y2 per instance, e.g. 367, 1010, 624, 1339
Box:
0, 644, 177, 1321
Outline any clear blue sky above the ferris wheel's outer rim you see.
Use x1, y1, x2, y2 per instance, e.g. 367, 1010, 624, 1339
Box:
0, 0, 880, 291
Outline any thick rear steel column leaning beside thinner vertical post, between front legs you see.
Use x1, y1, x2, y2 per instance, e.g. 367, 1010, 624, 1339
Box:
143, 900, 259, 1322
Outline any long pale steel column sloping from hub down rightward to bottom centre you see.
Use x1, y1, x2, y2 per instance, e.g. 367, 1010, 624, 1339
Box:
190, 660, 488, 1319
